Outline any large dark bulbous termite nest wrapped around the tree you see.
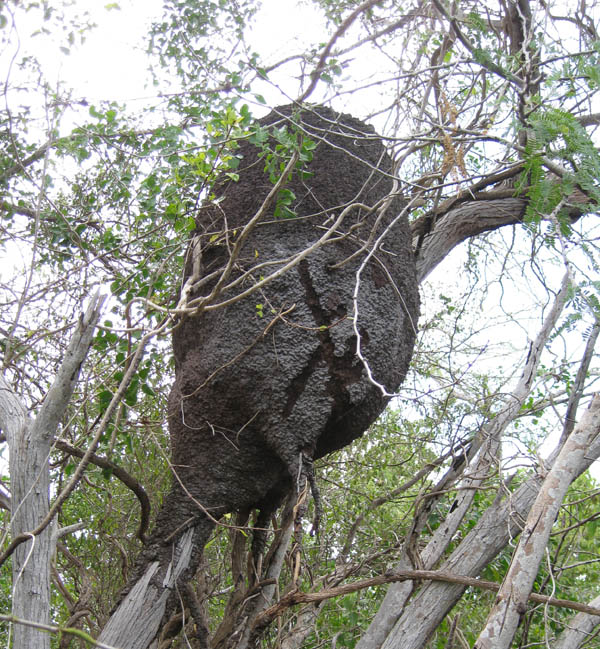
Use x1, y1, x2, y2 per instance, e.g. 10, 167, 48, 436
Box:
158, 107, 419, 535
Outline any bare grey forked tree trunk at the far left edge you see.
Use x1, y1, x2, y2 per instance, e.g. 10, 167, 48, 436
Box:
0, 296, 103, 649
